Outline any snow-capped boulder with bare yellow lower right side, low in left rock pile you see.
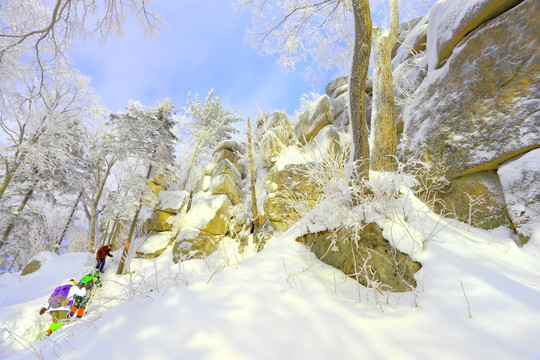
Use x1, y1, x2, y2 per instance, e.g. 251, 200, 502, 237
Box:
184, 191, 231, 235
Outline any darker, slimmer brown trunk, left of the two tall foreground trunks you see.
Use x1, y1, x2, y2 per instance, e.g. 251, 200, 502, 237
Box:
349, 0, 372, 177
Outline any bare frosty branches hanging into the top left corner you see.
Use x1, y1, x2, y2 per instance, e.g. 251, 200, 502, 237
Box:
0, 0, 161, 90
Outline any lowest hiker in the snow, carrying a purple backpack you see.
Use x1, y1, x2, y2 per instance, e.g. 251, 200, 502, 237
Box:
39, 279, 86, 336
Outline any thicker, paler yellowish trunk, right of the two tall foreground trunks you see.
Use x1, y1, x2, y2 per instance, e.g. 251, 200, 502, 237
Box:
371, 0, 399, 171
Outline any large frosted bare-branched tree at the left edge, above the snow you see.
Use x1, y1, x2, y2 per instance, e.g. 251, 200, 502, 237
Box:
0, 68, 93, 248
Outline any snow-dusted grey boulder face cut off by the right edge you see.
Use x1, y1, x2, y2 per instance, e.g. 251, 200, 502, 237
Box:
497, 149, 540, 244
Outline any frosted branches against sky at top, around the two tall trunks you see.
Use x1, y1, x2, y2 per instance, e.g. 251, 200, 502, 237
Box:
235, 0, 436, 80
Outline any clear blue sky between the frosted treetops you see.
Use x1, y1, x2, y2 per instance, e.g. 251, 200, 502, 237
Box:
72, 0, 326, 119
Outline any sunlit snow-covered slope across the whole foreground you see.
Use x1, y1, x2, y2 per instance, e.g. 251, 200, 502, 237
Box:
0, 205, 540, 360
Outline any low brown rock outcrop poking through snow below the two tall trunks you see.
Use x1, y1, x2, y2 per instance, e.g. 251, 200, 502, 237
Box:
296, 223, 422, 291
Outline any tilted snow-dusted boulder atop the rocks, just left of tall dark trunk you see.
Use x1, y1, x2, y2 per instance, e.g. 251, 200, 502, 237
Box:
294, 95, 334, 145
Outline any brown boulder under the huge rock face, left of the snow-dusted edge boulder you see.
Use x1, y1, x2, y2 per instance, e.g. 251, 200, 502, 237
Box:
435, 170, 511, 229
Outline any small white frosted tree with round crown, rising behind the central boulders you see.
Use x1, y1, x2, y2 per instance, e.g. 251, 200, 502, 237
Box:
182, 89, 242, 188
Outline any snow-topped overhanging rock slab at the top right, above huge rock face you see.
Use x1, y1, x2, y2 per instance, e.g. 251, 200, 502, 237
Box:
427, 0, 524, 71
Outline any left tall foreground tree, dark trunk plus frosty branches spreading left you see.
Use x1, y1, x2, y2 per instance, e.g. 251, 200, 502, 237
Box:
236, 0, 372, 175
